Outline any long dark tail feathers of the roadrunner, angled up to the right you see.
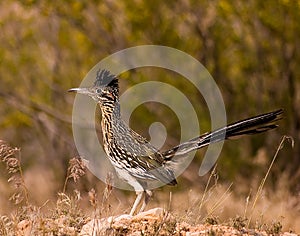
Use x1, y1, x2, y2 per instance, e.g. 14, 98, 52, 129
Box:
162, 109, 283, 161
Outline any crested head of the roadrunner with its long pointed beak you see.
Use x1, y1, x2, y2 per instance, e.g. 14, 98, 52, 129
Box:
68, 69, 119, 104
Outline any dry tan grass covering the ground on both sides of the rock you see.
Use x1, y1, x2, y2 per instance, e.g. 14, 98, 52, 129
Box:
0, 137, 300, 236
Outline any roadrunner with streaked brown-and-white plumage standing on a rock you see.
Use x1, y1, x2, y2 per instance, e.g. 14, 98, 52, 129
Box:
69, 70, 283, 215
